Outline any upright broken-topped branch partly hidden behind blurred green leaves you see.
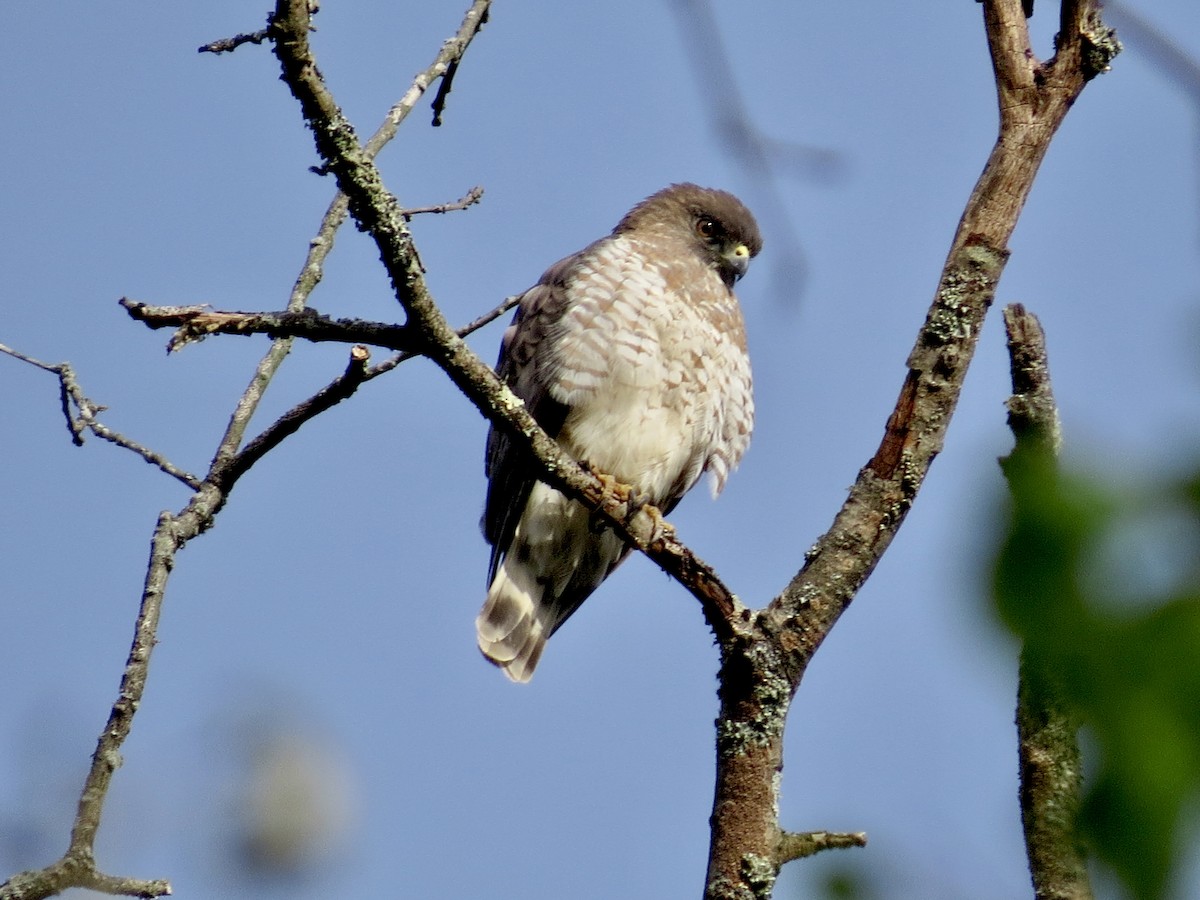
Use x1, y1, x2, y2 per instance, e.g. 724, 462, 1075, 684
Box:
1001, 304, 1092, 900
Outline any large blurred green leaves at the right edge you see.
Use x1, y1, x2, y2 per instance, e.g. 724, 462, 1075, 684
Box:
994, 450, 1200, 900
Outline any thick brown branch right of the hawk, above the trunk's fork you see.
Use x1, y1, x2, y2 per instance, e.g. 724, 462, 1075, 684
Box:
768, 0, 1118, 696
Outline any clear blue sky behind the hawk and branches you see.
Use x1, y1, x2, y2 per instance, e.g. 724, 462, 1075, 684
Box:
0, 0, 1200, 900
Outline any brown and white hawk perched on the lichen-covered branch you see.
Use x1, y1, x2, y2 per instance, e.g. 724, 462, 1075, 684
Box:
475, 184, 762, 682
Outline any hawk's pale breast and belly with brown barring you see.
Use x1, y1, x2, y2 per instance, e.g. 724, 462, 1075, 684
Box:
546, 236, 752, 505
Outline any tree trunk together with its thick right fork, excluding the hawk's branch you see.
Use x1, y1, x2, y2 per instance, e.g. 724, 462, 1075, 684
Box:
707, 0, 1120, 900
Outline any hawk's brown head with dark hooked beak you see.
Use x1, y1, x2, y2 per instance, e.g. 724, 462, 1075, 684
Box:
613, 182, 762, 288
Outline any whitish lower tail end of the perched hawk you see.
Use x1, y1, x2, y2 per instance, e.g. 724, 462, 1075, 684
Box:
475, 559, 551, 682
